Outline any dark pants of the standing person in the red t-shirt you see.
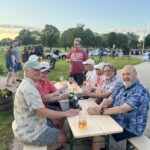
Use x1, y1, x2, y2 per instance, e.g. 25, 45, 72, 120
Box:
69, 73, 84, 85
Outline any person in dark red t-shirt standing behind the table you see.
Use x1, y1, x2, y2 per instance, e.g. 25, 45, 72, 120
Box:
66, 38, 88, 85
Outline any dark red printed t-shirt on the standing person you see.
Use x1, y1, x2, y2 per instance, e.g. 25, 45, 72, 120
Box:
67, 49, 88, 74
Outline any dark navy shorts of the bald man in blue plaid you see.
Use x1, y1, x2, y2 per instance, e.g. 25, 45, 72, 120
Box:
112, 129, 137, 142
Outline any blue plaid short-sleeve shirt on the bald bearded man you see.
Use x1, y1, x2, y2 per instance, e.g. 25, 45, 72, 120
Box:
111, 80, 150, 135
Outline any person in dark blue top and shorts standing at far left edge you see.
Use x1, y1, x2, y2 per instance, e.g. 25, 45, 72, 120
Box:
5, 46, 15, 86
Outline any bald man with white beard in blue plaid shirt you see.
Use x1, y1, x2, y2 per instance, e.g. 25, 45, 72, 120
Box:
88, 65, 150, 150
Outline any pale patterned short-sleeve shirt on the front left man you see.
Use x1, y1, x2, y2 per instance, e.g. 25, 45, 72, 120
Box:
12, 78, 47, 143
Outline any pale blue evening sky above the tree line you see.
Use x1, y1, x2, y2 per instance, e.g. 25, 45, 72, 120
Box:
0, 0, 150, 39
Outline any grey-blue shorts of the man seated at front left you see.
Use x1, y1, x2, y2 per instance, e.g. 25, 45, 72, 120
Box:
33, 121, 60, 146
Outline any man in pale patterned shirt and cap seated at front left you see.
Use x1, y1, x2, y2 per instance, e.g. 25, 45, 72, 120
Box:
12, 61, 78, 149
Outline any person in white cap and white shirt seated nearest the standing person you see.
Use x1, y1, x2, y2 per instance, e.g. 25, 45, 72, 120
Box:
83, 59, 96, 90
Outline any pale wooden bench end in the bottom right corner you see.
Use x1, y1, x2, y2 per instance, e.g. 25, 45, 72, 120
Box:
126, 135, 150, 150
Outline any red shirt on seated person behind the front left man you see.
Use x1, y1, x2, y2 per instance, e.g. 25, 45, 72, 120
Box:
36, 79, 57, 108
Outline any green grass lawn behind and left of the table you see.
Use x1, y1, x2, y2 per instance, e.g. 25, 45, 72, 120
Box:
0, 47, 142, 150
